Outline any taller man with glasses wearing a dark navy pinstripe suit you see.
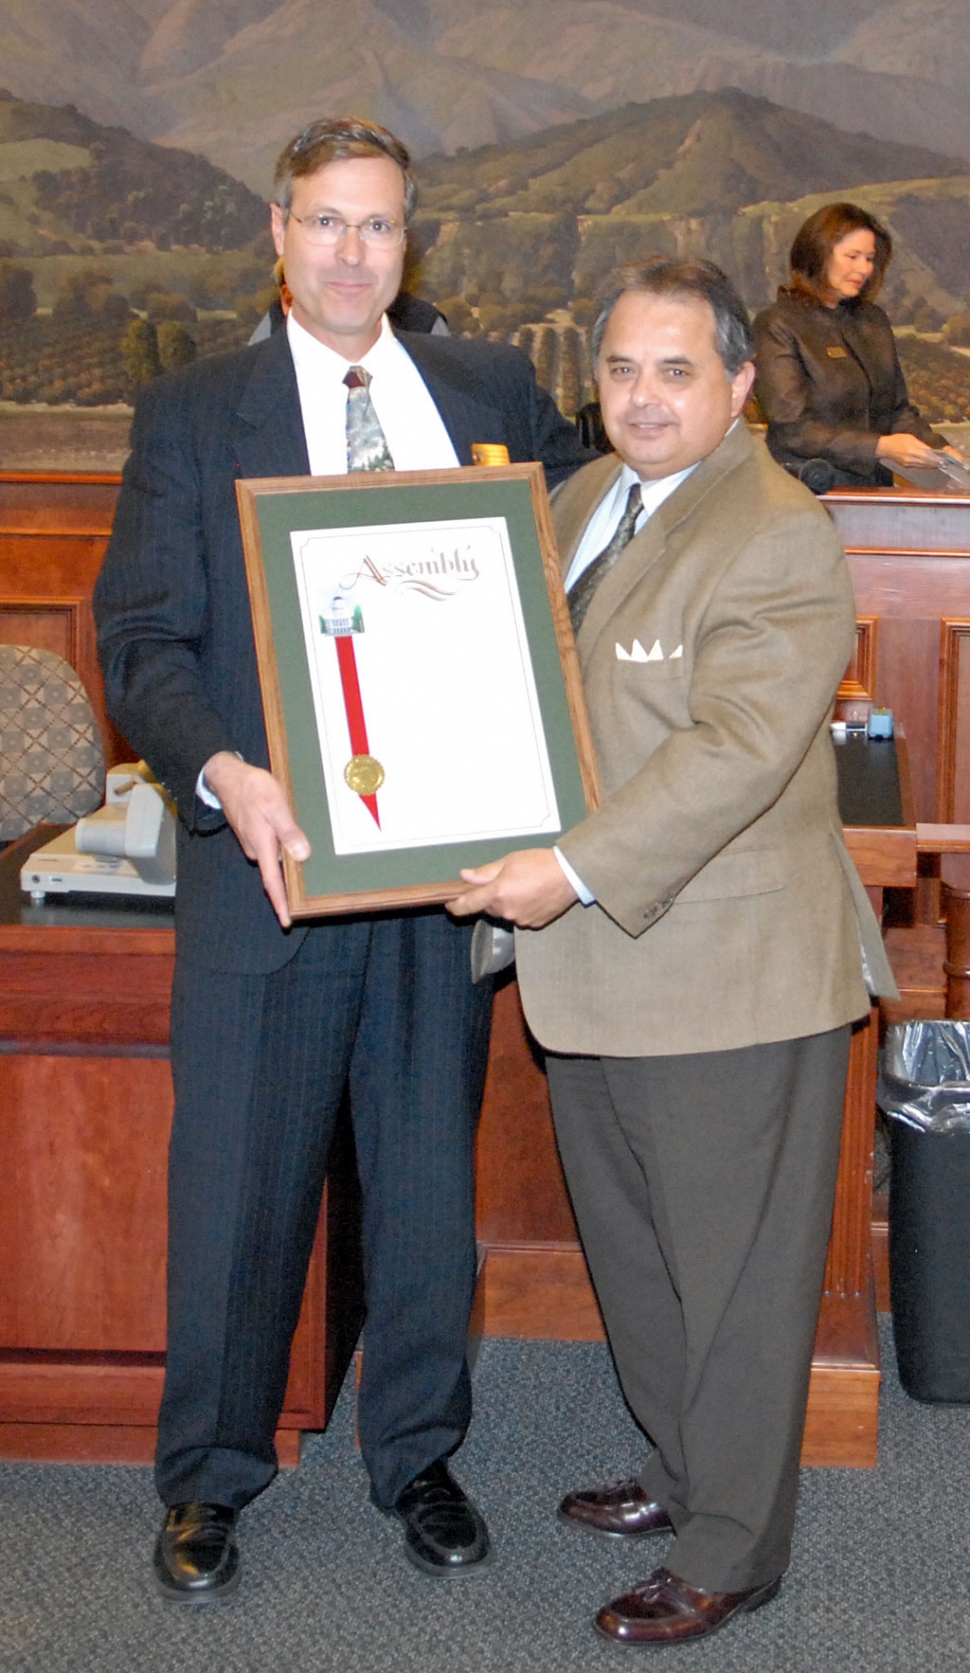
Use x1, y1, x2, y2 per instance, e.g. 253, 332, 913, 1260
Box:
95, 119, 587, 1601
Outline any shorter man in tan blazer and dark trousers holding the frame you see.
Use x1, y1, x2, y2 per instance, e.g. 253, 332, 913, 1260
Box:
452, 258, 891, 1645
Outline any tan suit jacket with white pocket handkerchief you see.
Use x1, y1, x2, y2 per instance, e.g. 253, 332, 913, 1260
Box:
517, 423, 891, 1057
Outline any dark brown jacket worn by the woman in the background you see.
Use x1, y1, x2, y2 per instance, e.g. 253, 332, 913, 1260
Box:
754, 291, 947, 487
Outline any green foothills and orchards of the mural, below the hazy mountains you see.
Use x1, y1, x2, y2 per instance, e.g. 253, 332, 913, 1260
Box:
0, 81, 970, 455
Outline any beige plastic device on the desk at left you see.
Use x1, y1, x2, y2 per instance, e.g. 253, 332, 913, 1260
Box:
20, 761, 176, 902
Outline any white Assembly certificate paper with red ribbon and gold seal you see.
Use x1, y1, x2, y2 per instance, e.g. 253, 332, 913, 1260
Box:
291, 515, 562, 855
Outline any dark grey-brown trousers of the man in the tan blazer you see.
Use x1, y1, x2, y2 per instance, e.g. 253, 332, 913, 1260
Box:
547, 1027, 850, 1591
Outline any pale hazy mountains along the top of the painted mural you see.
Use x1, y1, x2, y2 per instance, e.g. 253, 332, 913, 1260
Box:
0, 0, 970, 192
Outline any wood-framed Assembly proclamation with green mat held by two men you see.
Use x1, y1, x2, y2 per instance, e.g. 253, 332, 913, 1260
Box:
236, 465, 599, 918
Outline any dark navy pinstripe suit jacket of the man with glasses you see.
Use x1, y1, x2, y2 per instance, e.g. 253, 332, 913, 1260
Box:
94, 322, 592, 972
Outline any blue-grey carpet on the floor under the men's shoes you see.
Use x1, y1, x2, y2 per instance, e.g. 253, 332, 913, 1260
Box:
0, 1330, 970, 1673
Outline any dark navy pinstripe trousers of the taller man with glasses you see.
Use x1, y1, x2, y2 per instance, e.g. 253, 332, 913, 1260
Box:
156, 910, 492, 1509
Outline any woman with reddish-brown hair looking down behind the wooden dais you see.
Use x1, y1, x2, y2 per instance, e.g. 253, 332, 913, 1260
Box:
754, 204, 960, 489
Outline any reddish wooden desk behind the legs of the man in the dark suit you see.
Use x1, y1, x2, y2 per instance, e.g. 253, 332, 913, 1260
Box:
0, 831, 361, 1464
